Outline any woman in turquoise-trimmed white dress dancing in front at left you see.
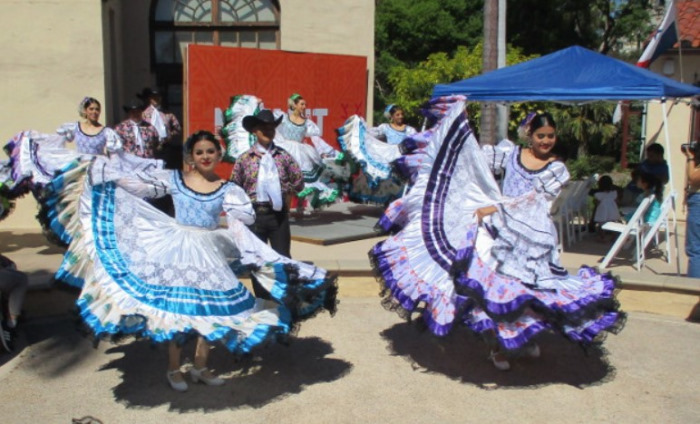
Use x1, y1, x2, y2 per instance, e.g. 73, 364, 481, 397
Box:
56, 131, 337, 391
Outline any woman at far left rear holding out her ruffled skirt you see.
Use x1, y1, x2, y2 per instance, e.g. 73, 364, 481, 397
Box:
5, 97, 131, 245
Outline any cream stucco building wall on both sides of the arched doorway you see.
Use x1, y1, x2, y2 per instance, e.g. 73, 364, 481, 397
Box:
0, 0, 375, 229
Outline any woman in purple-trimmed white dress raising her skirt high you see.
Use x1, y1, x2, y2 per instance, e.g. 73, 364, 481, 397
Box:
370, 97, 624, 370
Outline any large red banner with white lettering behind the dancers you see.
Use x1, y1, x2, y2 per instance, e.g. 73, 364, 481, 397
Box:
185, 44, 367, 172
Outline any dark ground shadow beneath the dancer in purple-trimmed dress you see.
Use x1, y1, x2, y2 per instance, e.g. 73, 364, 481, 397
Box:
381, 323, 614, 389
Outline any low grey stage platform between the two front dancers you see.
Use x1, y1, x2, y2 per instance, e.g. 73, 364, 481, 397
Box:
290, 202, 384, 245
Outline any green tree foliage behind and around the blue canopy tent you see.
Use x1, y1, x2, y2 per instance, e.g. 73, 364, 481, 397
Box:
375, 0, 653, 158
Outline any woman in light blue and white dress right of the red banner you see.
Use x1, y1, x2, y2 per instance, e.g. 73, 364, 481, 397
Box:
338, 104, 416, 204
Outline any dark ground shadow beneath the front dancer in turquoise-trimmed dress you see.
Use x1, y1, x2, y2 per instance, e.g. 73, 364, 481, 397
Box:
101, 337, 352, 412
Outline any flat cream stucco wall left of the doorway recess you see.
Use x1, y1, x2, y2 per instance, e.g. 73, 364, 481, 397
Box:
0, 0, 105, 229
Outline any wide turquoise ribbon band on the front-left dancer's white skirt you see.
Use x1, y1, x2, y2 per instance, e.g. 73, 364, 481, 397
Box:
92, 183, 255, 316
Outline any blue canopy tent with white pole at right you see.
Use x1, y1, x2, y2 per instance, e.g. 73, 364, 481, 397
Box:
433, 46, 700, 273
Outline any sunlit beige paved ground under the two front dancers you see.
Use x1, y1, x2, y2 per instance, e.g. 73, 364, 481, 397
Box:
0, 219, 700, 424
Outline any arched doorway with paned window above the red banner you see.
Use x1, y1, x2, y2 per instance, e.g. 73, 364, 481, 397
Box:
149, 0, 280, 116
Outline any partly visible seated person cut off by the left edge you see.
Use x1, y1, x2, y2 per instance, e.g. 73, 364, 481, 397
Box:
0, 254, 29, 352
